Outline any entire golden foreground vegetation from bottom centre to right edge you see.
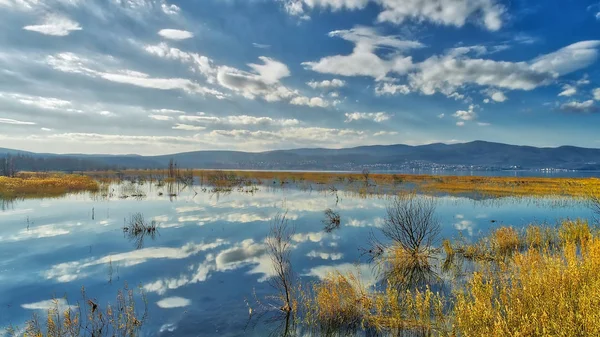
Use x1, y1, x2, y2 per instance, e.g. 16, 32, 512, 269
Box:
302, 220, 600, 337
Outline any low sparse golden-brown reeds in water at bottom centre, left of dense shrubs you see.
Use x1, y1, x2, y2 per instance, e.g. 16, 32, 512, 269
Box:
303, 272, 449, 336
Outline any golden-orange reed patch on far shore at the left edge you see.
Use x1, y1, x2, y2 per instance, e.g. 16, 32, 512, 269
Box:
0, 173, 99, 199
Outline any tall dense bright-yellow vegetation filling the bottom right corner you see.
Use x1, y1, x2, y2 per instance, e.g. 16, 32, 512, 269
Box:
453, 221, 600, 336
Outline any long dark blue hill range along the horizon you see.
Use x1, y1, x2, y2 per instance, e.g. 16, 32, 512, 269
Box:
0, 141, 600, 170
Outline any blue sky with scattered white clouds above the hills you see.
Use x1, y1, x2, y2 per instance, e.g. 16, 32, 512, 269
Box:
0, 0, 600, 155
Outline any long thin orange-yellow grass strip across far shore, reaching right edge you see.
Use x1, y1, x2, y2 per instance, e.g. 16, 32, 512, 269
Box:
79, 170, 600, 198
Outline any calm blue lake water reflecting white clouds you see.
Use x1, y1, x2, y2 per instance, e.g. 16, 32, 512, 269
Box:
0, 184, 592, 336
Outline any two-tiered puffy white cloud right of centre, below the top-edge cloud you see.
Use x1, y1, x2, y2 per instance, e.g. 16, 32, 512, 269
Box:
302, 26, 423, 80
